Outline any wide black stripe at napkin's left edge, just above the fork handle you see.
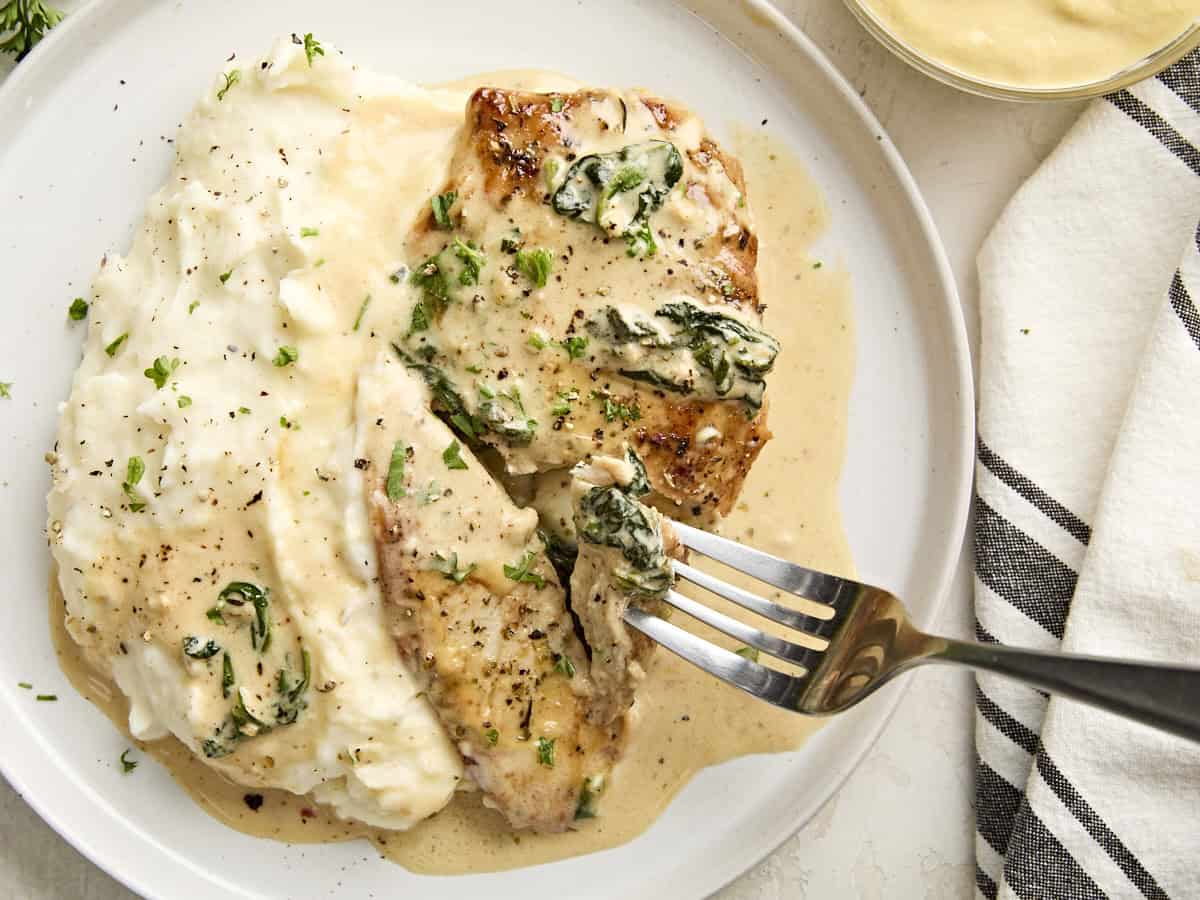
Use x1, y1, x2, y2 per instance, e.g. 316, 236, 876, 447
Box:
976, 496, 1076, 640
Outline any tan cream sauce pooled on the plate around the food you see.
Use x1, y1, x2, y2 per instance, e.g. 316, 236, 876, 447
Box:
50, 61, 854, 875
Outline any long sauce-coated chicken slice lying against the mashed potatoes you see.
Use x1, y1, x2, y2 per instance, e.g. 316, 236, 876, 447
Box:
358, 359, 624, 832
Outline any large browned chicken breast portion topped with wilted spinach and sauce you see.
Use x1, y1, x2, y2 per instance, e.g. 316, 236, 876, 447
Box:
397, 88, 779, 522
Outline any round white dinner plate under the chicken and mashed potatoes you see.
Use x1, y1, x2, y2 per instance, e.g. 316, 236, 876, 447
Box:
0, 0, 973, 900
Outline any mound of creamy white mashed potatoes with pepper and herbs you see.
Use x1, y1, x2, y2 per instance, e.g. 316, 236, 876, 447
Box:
49, 38, 477, 828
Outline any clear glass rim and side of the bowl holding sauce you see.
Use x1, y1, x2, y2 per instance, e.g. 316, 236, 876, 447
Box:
846, 0, 1200, 102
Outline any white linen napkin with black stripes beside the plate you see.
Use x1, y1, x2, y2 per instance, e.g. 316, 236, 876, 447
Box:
976, 52, 1200, 900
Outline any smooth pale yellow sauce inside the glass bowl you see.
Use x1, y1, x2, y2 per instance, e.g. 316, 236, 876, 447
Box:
854, 0, 1200, 91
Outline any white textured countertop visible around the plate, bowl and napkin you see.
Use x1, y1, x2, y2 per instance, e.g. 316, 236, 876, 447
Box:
0, 0, 1080, 900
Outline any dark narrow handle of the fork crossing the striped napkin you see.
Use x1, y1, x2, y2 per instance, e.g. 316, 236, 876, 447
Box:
922, 638, 1200, 740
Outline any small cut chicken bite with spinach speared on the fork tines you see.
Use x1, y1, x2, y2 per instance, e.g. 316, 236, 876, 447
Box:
571, 450, 682, 722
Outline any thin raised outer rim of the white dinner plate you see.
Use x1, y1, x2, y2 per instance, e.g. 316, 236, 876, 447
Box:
0, 0, 976, 898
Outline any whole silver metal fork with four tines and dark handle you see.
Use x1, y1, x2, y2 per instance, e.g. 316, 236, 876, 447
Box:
625, 522, 1200, 740
